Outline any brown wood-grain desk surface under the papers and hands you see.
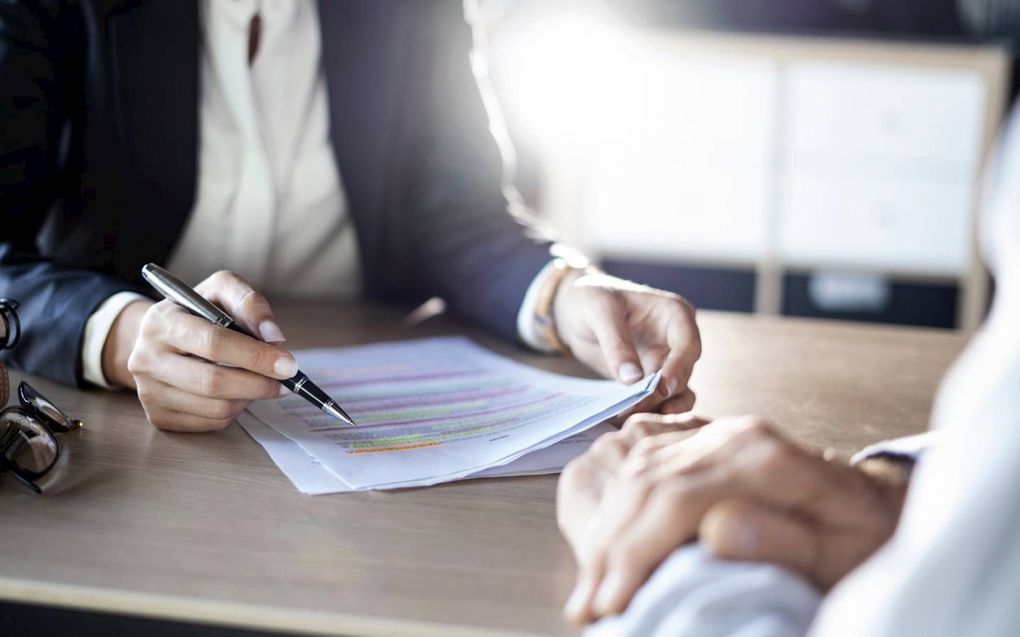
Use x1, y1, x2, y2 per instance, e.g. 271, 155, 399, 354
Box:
0, 304, 964, 636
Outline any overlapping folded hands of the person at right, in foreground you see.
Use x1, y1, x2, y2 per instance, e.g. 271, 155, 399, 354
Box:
558, 418, 906, 622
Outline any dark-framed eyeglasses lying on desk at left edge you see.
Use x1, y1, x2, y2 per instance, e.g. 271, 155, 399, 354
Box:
0, 381, 84, 493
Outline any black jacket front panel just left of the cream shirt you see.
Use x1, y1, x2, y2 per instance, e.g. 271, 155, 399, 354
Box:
107, 0, 201, 280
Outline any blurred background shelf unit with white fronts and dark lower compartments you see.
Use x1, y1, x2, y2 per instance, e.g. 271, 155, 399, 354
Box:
489, 2, 1012, 330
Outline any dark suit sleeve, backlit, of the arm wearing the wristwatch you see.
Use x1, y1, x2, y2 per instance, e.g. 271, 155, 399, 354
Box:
394, 0, 550, 338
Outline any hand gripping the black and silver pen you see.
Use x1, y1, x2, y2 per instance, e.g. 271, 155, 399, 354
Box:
103, 272, 298, 431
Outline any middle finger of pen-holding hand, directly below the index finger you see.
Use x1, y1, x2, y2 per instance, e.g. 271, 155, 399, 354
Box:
144, 354, 283, 401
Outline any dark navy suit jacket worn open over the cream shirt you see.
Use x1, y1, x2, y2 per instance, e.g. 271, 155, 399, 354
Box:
0, 0, 549, 383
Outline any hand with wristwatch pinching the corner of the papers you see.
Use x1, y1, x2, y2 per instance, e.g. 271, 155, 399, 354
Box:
553, 272, 701, 414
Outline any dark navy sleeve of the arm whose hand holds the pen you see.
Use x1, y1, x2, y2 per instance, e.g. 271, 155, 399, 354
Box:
0, 1, 131, 384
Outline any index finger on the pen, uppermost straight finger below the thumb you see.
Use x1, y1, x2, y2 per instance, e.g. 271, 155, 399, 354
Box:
153, 311, 298, 380
